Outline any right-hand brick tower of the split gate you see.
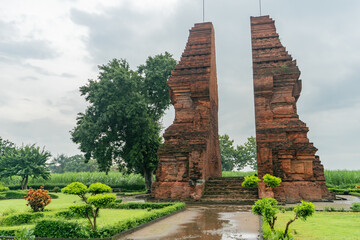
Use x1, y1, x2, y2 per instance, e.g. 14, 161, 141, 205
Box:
251, 16, 332, 202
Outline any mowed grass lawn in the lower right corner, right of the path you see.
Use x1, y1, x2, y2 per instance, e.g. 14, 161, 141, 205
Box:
275, 212, 360, 240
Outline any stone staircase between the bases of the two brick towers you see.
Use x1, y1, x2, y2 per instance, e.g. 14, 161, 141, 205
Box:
200, 177, 259, 205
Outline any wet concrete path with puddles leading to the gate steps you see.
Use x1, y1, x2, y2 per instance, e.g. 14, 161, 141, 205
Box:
123, 205, 260, 240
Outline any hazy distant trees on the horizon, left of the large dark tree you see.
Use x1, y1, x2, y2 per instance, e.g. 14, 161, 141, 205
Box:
49, 154, 98, 173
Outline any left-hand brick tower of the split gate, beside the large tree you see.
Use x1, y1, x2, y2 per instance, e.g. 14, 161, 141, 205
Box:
152, 23, 221, 200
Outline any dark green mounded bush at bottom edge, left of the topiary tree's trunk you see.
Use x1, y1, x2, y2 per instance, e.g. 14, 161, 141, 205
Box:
34, 220, 88, 239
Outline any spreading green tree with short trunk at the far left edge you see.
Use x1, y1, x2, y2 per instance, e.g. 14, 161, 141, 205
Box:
0, 145, 51, 190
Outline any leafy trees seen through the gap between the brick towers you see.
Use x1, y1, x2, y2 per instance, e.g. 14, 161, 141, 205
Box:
219, 134, 257, 171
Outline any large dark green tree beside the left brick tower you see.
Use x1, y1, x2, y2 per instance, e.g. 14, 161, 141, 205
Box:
71, 53, 176, 190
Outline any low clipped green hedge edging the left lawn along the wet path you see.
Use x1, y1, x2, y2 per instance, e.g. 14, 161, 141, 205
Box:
32, 203, 185, 239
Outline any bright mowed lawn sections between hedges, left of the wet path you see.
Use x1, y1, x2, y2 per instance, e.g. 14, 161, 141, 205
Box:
0, 193, 148, 230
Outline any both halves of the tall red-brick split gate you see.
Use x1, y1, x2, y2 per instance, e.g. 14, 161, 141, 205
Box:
152, 16, 332, 202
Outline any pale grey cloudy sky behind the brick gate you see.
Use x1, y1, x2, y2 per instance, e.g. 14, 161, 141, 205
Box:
0, 0, 360, 169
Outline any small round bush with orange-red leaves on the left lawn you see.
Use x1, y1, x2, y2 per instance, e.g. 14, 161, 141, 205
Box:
25, 187, 51, 212
